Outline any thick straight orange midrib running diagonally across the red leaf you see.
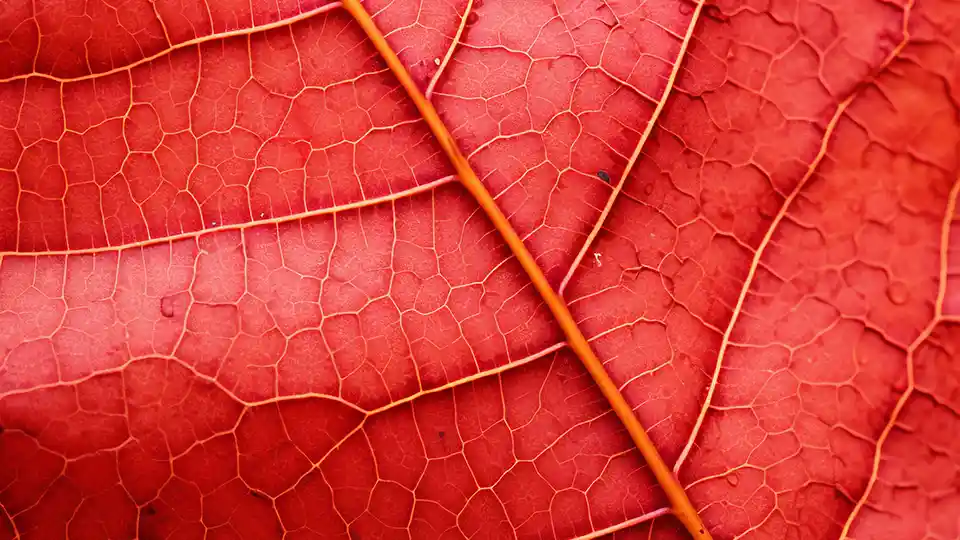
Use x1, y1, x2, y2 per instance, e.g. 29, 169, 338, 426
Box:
343, 0, 712, 540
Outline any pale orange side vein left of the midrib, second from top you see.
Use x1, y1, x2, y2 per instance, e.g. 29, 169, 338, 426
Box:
0, 176, 455, 259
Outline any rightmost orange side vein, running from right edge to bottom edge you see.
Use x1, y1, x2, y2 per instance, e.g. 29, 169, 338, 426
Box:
840, 175, 960, 540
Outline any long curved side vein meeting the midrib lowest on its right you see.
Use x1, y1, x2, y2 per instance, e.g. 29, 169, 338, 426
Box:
673, 0, 913, 473
